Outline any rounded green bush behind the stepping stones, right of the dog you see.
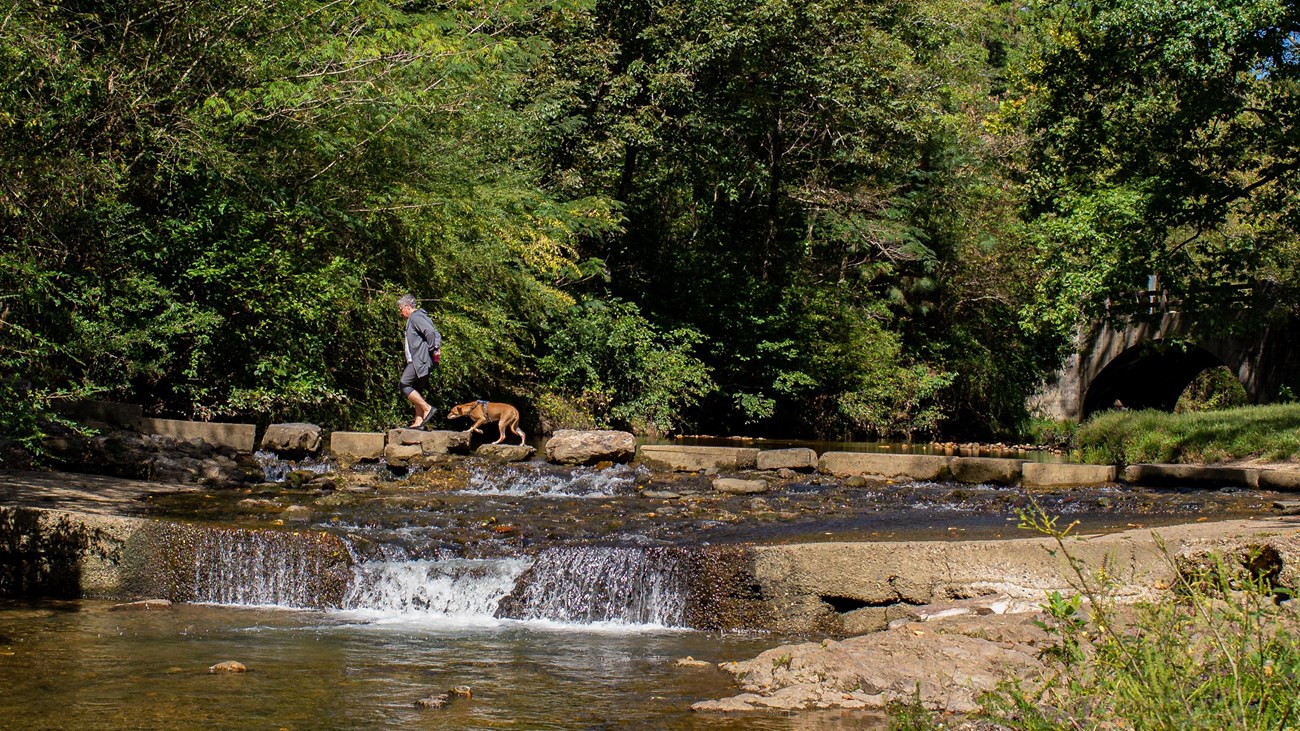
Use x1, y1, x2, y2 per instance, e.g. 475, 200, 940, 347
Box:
537, 299, 714, 433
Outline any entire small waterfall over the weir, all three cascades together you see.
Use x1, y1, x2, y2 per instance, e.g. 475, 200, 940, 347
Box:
133, 523, 692, 627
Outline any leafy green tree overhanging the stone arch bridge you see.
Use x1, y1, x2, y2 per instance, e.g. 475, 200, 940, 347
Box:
1005, 0, 1300, 333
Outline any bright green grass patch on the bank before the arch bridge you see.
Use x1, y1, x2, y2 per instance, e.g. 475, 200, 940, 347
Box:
1074, 403, 1300, 466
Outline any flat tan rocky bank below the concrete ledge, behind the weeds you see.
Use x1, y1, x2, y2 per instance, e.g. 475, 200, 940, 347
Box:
693, 523, 1300, 714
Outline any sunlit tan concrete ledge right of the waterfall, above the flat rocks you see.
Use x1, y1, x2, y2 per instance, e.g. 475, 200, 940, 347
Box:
754, 517, 1300, 633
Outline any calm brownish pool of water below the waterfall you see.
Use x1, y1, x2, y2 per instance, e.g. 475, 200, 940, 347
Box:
0, 602, 880, 731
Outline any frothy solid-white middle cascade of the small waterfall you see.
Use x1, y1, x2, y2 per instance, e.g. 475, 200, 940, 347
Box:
343, 558, 529, 619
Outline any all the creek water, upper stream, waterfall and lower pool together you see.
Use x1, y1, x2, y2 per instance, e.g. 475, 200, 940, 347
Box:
0, 450, 1275, 730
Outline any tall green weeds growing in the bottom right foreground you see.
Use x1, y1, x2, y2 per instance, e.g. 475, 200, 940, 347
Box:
984, 506, 1300, 731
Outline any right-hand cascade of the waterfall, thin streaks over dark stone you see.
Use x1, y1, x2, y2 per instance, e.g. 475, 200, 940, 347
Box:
498, 546, 686, 627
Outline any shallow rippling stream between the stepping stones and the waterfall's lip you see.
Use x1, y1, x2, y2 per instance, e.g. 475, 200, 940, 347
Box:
134, 459, 1278, 558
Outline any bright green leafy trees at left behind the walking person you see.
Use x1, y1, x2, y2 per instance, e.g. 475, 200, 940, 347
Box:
0, 0, 614, 444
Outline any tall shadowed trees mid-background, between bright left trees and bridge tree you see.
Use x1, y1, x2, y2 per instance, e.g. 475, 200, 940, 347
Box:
527, 0, 1041, 436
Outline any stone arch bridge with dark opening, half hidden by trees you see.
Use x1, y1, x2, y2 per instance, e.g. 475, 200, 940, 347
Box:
1030, 291, 1300, 421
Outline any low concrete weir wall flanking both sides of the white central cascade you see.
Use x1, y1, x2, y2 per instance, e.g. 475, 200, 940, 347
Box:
0, 499, 1300, 636
